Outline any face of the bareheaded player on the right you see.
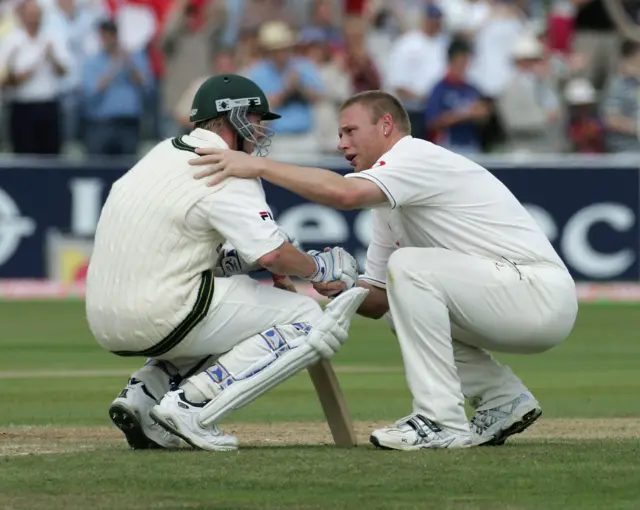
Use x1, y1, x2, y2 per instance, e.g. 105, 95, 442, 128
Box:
338, 103, 385, 172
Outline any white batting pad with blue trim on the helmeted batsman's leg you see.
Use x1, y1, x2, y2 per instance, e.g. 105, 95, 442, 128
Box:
198, 288, 368, 427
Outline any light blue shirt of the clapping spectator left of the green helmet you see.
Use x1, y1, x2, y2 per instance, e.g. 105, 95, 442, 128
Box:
82, 52, 152, 120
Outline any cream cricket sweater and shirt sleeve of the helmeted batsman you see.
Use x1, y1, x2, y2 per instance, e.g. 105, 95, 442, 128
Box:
86, 129, 284, 357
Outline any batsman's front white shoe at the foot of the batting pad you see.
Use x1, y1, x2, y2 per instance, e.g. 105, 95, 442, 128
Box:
151, 390, 238, 452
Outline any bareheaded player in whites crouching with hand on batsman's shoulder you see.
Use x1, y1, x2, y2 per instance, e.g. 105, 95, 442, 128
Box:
193, 91, 578, 450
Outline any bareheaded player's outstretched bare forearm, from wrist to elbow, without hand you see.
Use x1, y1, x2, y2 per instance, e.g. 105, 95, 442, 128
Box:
261, 159, 349, 208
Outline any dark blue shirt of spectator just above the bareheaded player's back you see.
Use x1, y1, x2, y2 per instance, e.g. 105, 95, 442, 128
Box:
425, 77, 481, 152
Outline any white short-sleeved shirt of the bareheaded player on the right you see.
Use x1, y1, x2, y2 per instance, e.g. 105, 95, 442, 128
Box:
346, 136, 566, 287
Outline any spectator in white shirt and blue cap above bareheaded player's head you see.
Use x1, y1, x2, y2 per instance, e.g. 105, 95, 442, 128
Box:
386, 5, 449, 138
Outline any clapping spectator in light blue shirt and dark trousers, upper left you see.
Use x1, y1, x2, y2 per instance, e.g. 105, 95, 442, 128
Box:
82, 21, 151, 156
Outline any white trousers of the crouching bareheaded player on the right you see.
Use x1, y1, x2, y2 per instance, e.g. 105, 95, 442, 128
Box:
387, 248, 578, 433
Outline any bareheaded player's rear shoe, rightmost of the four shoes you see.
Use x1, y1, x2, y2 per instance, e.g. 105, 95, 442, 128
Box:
471, 392, 542, 446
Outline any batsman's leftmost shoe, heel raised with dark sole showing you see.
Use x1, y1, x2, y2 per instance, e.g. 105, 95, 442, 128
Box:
109, 378, 180, 450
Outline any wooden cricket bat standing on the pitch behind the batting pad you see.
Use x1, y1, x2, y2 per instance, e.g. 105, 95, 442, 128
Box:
272, 274, 357, 448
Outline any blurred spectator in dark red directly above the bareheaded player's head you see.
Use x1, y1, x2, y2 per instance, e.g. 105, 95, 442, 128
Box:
341, 16, 381, 92
